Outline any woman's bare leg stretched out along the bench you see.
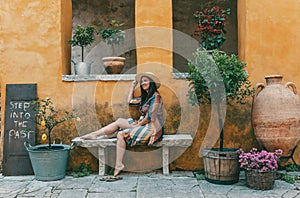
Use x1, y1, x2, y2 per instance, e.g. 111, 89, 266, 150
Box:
81, 118, 131, 140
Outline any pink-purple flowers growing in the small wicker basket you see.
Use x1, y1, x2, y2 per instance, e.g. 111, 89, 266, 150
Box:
238, 148, 282, 172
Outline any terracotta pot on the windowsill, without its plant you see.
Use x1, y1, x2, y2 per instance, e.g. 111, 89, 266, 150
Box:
102, 57, 125, 74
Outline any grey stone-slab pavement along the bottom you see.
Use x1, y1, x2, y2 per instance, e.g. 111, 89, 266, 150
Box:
0, 171, 300, 198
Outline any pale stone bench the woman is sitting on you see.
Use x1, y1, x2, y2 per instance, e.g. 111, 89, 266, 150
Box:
72, 134, 193, 176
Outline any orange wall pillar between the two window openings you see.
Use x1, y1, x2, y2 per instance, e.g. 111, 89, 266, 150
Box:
135, 0, 173, 75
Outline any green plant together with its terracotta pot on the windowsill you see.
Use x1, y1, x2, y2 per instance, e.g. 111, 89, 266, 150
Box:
97, 20, 125, 74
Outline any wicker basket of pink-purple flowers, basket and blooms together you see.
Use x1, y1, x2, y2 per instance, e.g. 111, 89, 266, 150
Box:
238, 148, 283, 190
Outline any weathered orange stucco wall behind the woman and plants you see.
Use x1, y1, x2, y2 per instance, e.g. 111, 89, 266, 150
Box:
0, 0, 300, 170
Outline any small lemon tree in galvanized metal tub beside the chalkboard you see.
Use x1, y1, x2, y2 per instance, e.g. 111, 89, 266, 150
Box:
24, 98, 79, 181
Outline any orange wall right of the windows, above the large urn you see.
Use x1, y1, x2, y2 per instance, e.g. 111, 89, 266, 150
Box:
238, 0, 300, 87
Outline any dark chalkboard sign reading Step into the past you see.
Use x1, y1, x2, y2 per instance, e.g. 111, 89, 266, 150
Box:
2, 84, 37, 175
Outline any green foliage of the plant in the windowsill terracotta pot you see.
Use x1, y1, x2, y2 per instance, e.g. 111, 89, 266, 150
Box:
97, 20, 125, 45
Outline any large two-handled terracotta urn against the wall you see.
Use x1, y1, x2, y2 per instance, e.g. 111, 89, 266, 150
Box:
252, 75, 300, 157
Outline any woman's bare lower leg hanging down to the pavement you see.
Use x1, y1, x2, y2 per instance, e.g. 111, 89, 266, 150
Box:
114, 133, 126, 176
